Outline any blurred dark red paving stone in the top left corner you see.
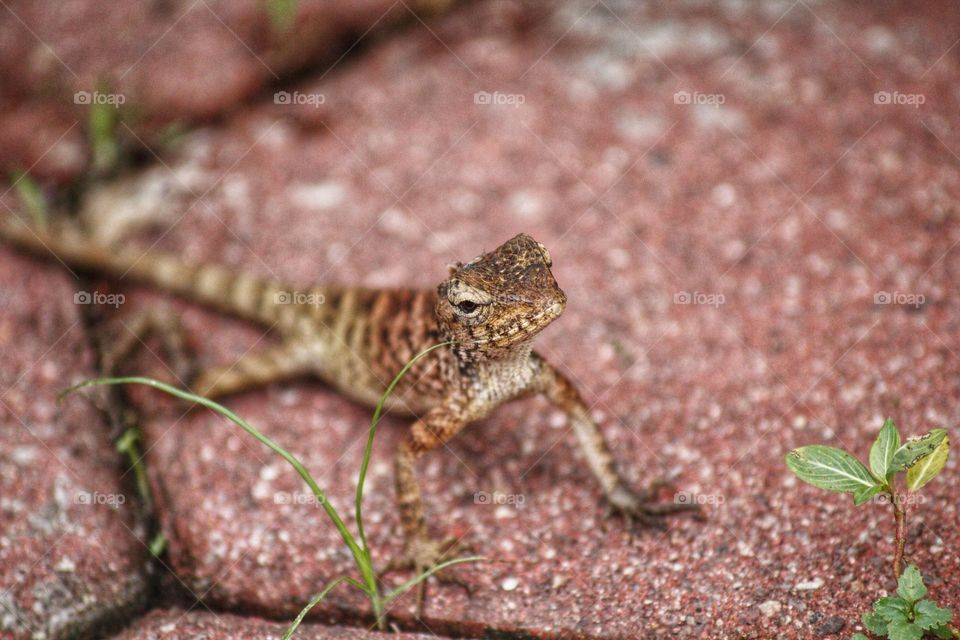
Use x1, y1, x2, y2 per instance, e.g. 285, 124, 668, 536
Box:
0, 0, 446, 182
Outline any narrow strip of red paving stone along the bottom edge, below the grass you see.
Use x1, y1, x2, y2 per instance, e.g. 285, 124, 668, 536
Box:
114, 609, 442, 640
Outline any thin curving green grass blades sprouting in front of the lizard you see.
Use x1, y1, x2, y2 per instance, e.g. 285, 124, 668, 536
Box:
60, 342, 485, 640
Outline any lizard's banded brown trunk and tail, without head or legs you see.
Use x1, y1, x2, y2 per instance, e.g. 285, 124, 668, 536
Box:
0, 223, 456, 413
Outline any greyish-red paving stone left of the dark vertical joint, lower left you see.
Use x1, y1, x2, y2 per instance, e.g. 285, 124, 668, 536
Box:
0, 247, 148, 640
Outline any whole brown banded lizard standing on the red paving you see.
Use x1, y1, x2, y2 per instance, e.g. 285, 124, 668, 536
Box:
0, 222, 697, 615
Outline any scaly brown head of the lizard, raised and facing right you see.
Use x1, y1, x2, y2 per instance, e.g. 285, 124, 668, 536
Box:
436, 234, 567, 361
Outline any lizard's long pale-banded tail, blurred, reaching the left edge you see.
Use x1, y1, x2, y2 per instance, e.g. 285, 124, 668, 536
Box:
0, 222, 304, 325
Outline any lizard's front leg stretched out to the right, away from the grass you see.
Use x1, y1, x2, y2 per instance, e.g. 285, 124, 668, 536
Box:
534, 359, 699, 526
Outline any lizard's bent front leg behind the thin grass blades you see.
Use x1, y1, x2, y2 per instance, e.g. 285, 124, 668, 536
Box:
391, 399, 471, 617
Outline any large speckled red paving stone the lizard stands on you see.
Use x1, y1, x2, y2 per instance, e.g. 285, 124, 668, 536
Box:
1, 2, 960, 638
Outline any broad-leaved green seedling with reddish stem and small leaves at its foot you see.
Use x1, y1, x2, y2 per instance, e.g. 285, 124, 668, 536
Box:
786, 418, 960, 640
